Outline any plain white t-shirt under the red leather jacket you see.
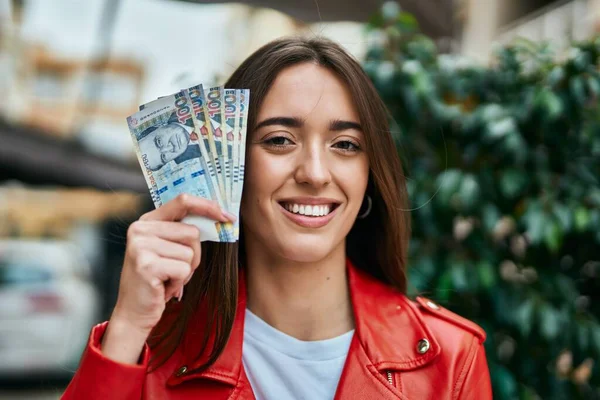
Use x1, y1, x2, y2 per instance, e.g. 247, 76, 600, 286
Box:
242, 309, 354, 400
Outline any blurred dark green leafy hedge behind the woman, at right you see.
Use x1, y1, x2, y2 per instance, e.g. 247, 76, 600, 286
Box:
364, 3, 600, 399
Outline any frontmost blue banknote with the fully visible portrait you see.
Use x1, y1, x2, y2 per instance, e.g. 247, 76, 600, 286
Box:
127, 92, 227, 242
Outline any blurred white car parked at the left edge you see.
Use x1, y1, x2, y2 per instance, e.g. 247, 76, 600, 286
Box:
0, 240, 100, 377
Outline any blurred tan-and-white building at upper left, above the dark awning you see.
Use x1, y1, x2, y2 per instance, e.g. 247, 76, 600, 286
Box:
5, 44, 144, 139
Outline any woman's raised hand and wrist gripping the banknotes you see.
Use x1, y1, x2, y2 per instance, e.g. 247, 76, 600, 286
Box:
102, 194, 234, 364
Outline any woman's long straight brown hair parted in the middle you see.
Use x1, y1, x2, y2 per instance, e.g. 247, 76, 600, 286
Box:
149, 37, 410, 370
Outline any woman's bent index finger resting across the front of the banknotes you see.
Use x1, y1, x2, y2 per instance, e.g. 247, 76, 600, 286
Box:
140, 194, 235, 222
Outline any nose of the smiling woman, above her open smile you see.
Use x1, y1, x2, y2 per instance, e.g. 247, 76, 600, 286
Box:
294, 143, 331, 188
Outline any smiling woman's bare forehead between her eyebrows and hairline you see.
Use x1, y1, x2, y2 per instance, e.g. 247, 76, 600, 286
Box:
258, 63, 359, 122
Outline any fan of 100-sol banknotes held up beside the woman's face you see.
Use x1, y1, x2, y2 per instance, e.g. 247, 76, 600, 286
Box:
127, 85, 250, 242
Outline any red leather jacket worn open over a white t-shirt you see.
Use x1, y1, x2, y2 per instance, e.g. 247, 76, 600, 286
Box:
62, 263, 492, 400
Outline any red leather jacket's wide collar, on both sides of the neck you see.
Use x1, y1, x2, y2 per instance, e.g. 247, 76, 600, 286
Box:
167, 261, 440, 385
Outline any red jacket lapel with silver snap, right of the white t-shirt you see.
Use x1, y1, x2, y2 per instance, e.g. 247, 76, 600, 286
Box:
336, 261, 440, 400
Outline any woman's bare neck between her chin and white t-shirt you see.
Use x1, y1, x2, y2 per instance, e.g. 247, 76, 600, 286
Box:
246, 243, 354, 341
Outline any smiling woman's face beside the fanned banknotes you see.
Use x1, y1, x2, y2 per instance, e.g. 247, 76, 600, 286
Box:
242, 63, 369, 262
